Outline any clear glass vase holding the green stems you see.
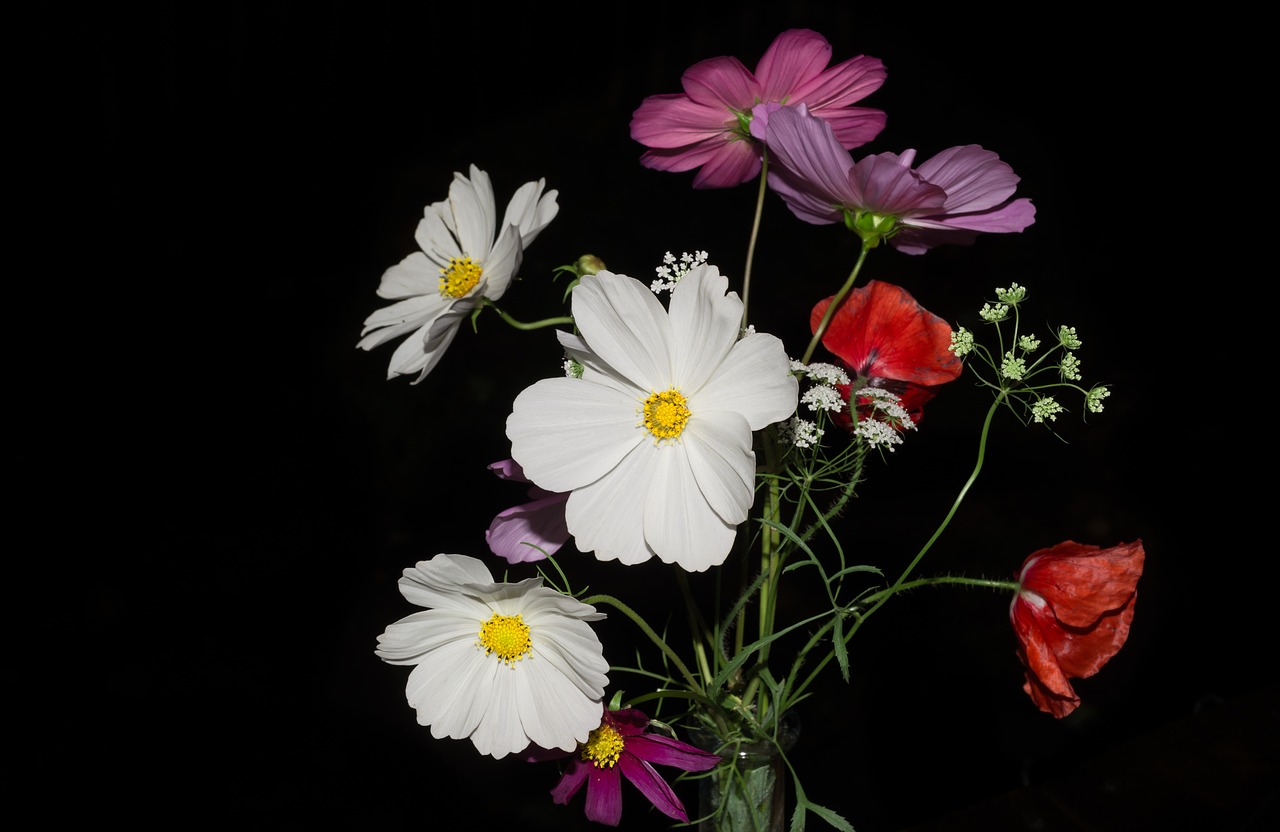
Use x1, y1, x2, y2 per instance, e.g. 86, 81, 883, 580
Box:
691, 713, 800, 832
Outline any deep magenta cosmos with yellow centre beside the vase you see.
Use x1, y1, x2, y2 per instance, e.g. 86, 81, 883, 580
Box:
527, 708, 721, 826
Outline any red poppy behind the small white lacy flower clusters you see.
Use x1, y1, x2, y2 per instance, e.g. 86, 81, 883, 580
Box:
809, 280, 964, 428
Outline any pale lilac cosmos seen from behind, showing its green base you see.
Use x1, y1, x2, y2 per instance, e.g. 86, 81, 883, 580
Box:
751, 106, 1036, 249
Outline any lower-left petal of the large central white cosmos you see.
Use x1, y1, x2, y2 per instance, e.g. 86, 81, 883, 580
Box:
563, 440, 657, 566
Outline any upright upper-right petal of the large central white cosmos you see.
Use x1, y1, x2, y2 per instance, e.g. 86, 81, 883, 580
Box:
671, 265, 742, 396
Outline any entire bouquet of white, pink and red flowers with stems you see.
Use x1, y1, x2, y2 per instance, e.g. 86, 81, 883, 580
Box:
358, 29, 1144, 829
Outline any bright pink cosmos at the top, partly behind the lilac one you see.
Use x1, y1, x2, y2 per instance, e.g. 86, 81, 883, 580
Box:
631, 29, 884, 188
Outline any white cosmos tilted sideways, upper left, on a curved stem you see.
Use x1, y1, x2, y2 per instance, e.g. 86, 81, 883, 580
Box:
356, 165, 559, 384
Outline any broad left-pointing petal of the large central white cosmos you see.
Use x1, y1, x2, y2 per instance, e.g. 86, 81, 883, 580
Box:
507, 378, 652, 491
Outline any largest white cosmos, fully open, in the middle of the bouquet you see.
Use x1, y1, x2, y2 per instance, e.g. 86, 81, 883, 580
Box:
507, 265, 799, 572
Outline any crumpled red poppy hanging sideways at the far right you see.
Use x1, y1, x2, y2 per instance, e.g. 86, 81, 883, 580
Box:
1009, 540, 1146, 718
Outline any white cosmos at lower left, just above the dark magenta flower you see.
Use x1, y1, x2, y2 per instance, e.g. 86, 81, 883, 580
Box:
376, 554, 609, 758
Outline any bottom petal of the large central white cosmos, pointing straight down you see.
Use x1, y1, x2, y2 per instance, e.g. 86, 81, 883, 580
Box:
644, 444, 736, 572
